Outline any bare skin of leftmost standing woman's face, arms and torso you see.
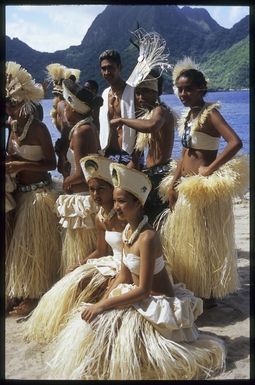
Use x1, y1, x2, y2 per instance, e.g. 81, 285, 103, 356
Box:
5, 103, 56, 184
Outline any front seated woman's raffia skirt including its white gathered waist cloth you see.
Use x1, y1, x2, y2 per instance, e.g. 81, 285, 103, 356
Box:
48, 284, 225, 380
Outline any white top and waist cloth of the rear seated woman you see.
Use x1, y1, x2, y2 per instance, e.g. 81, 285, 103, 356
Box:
84, 230, 122, 277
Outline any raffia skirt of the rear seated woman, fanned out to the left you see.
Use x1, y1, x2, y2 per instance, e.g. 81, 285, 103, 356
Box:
23, 255, 121, 343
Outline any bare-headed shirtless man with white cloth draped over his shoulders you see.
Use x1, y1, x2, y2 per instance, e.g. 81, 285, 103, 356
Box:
99, 50, 136, 164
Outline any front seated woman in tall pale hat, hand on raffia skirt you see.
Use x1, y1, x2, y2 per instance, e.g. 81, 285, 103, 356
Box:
49, 163, 225, 380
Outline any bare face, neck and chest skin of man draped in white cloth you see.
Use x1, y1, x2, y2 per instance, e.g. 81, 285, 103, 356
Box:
100, 59, 126, 151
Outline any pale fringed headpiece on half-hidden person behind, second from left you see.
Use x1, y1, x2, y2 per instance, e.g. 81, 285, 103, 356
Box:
46, 63, 81, 95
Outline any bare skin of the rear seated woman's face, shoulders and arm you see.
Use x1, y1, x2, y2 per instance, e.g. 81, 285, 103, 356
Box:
67, 178, 126, 272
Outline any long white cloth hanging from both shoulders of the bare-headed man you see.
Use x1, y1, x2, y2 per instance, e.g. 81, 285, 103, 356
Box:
99, 84, 136, 154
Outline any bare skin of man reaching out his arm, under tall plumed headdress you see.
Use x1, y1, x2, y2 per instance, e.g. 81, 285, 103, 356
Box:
111, 87, 174, 167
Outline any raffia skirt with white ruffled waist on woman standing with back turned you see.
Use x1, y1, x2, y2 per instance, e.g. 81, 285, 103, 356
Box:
56, 193, 98, 277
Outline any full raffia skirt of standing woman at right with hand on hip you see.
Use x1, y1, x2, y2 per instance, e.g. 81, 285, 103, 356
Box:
161, 156, 248, 298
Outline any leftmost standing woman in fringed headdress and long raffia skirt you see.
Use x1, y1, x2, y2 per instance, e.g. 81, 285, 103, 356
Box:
5, 62, 61, 315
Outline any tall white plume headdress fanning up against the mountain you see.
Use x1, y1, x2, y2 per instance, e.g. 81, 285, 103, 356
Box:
127, 28, 171, 87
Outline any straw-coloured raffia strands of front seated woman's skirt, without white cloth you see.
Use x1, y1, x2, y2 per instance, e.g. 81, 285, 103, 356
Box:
48, 304, 225, 380
